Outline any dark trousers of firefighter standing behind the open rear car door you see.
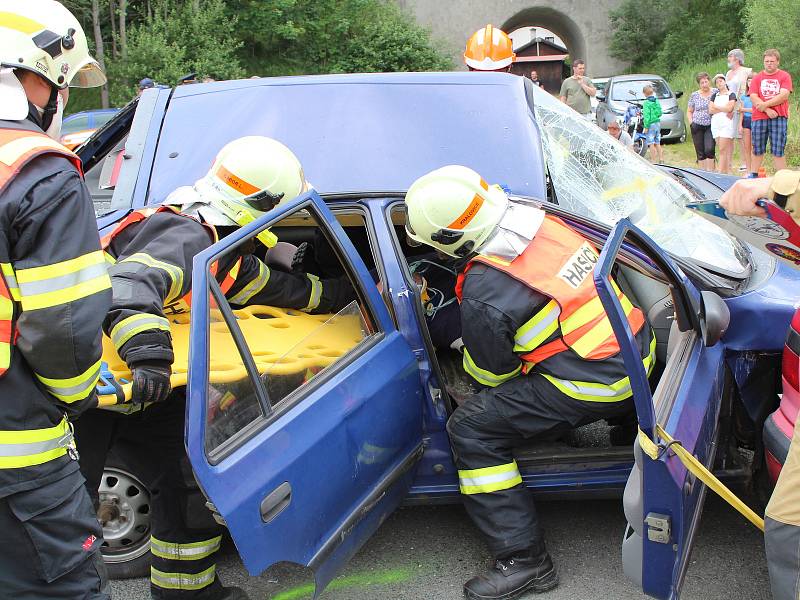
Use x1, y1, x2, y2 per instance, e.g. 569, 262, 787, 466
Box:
75, 391, 223, 600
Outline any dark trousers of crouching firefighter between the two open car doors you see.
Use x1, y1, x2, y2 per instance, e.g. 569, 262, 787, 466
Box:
447, 374, 633, 558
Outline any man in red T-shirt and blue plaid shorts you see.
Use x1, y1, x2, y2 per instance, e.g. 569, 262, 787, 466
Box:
750, 48, 792, 177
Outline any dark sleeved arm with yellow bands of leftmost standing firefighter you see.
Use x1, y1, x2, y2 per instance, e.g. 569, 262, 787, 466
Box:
12, 157, 111, 415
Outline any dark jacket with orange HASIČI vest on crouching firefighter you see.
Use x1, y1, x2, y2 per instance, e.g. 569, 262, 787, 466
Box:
457, 217, 655, 402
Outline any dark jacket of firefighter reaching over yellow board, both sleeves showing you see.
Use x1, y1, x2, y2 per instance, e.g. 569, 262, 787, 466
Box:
103, 206, 354, 366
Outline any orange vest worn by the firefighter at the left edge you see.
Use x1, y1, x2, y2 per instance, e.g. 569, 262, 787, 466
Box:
0, 128, 83, 377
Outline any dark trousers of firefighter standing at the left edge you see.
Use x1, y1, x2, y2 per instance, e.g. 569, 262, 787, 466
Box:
0, 471, 109, 600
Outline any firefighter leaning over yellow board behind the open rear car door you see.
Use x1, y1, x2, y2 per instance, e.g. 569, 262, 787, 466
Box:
76, 136, 353, 600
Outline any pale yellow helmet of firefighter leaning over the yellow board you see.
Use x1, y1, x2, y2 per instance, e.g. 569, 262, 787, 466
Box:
194, 135, 307, 239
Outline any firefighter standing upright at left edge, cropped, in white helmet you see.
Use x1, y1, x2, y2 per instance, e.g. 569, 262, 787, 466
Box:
0, 0, 111, 600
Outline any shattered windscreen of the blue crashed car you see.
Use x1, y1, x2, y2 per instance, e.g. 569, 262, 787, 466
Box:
533, 87, 749, 276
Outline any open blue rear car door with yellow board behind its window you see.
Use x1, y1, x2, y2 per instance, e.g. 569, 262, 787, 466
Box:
186, 192, 423, 592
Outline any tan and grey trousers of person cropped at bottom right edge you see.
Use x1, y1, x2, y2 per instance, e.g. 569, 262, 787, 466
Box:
764, 415, 800, 600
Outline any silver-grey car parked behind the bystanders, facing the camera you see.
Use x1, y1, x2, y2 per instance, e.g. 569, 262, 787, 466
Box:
595, 74, 686, 142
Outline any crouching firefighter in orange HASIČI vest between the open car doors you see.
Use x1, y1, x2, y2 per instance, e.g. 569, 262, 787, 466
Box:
405, 166, 655, 599
